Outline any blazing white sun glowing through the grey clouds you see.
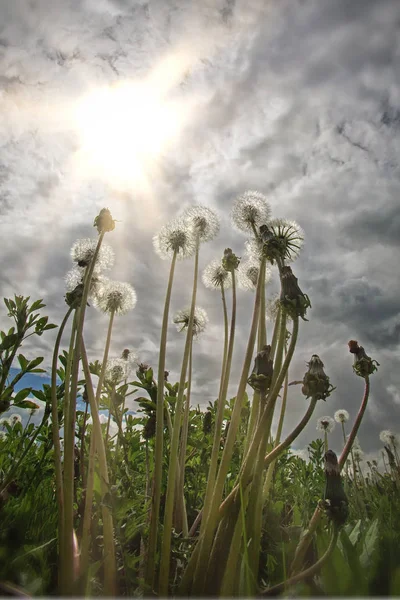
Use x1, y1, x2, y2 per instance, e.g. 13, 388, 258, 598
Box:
75, 82, 182, 183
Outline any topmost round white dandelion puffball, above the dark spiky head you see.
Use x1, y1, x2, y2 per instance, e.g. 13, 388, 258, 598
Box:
231, 191, 271, 232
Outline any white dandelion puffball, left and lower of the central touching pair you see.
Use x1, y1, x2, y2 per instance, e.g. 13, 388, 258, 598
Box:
153, 219, 196, 260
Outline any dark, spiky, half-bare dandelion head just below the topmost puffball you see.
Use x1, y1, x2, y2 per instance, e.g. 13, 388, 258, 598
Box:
260, 219, 304, 262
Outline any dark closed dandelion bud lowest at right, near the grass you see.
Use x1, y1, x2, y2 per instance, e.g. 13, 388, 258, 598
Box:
324, 450, 349, 527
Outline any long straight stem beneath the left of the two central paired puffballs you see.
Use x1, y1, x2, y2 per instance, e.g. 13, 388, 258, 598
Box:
145, 252, 177, 589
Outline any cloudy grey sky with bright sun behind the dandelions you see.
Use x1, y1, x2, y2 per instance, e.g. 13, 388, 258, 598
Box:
0, 0, 400, 464
